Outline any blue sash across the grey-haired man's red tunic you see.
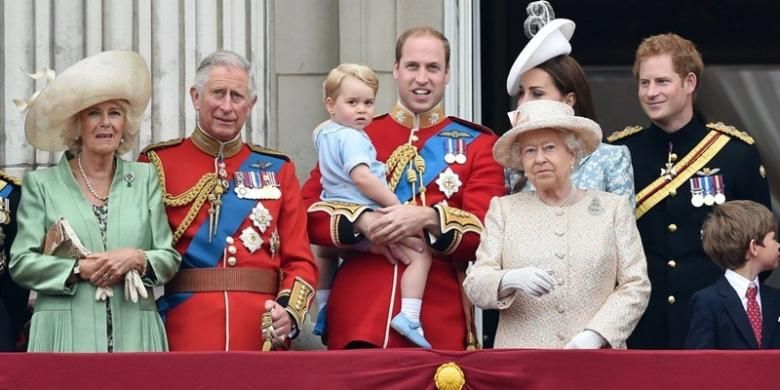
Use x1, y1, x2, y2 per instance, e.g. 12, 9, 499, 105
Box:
157, 152, 285, 315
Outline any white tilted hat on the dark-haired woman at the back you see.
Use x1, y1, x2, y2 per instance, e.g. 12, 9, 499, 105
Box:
506, 18, 575, 96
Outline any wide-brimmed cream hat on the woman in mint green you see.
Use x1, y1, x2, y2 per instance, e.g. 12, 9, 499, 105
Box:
24, 50, 152, 152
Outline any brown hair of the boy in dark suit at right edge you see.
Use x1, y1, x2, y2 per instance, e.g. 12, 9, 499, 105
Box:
701, 200, 777, 269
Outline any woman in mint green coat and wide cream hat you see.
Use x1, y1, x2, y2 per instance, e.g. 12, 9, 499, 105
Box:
10, 51, 181, 352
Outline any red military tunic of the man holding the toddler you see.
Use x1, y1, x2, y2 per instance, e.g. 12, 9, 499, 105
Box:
302, 104, 506, 350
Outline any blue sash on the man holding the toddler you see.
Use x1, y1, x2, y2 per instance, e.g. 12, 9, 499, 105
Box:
395, 123, 480, 202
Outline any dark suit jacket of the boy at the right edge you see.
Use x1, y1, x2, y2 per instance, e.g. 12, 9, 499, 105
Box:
685, 276, 780, 349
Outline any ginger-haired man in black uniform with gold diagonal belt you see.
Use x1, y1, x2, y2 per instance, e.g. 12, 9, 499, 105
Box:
608, 33, 770, 349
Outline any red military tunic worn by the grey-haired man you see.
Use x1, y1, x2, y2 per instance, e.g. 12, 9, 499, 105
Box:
141, 129, 317, 351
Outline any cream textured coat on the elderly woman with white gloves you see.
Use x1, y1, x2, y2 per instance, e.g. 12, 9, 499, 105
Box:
464, 190, 650, 348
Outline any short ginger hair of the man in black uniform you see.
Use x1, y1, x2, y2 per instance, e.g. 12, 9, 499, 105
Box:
634, 33, 704, 89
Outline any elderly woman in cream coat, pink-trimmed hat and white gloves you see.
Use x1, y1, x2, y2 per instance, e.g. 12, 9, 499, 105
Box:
464, 100, 650, 348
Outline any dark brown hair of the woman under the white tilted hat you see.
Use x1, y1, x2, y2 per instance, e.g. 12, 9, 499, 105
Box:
536, 54, 598, 122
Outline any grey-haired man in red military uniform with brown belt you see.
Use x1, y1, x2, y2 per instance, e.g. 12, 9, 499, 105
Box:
140, 50, 317, 351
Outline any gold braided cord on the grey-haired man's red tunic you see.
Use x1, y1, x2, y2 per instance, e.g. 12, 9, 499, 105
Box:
147, 151, 217, 245
